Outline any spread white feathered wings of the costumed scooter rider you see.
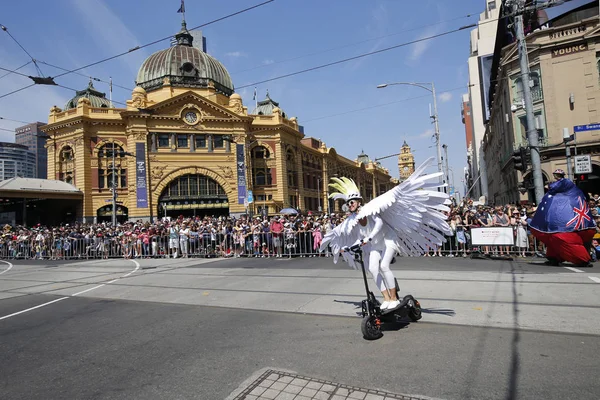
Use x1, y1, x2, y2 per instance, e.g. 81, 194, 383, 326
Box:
321, 157, 451, 262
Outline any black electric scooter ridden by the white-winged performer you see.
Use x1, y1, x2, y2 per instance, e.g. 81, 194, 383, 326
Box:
344, 244, 422, 340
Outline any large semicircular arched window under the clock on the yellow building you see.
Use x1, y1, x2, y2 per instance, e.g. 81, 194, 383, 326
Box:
157, 174, 229, 217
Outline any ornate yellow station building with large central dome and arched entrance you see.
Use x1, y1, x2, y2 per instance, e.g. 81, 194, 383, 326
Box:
44, 22, 396, 222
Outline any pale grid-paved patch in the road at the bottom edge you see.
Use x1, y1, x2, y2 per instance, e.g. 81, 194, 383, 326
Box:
232, 369, 440, 400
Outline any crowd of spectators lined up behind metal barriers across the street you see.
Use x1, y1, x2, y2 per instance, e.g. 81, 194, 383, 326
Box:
0, 195, 600, 259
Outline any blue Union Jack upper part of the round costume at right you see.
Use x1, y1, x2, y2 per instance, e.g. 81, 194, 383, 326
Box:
530, 179, 596, 233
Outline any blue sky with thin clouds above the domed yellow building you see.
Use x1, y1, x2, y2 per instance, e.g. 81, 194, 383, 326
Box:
0, 0, 592, 192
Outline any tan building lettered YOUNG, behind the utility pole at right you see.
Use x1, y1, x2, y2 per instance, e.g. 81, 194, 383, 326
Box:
483, 2, 600, 203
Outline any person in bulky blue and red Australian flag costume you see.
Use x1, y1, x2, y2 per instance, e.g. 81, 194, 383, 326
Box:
529, 169, 596, 267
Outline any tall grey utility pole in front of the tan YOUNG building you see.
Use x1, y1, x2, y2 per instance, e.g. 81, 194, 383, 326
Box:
512, 0, 544, 205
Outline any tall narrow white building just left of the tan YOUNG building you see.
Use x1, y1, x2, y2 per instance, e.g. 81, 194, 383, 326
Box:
463, 0, 501, 198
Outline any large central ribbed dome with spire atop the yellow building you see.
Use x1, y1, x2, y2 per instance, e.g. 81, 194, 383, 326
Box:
136, 22, 234, 96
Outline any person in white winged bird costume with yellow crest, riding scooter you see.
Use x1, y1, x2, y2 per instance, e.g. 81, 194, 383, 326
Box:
321, 158, 451, 310
